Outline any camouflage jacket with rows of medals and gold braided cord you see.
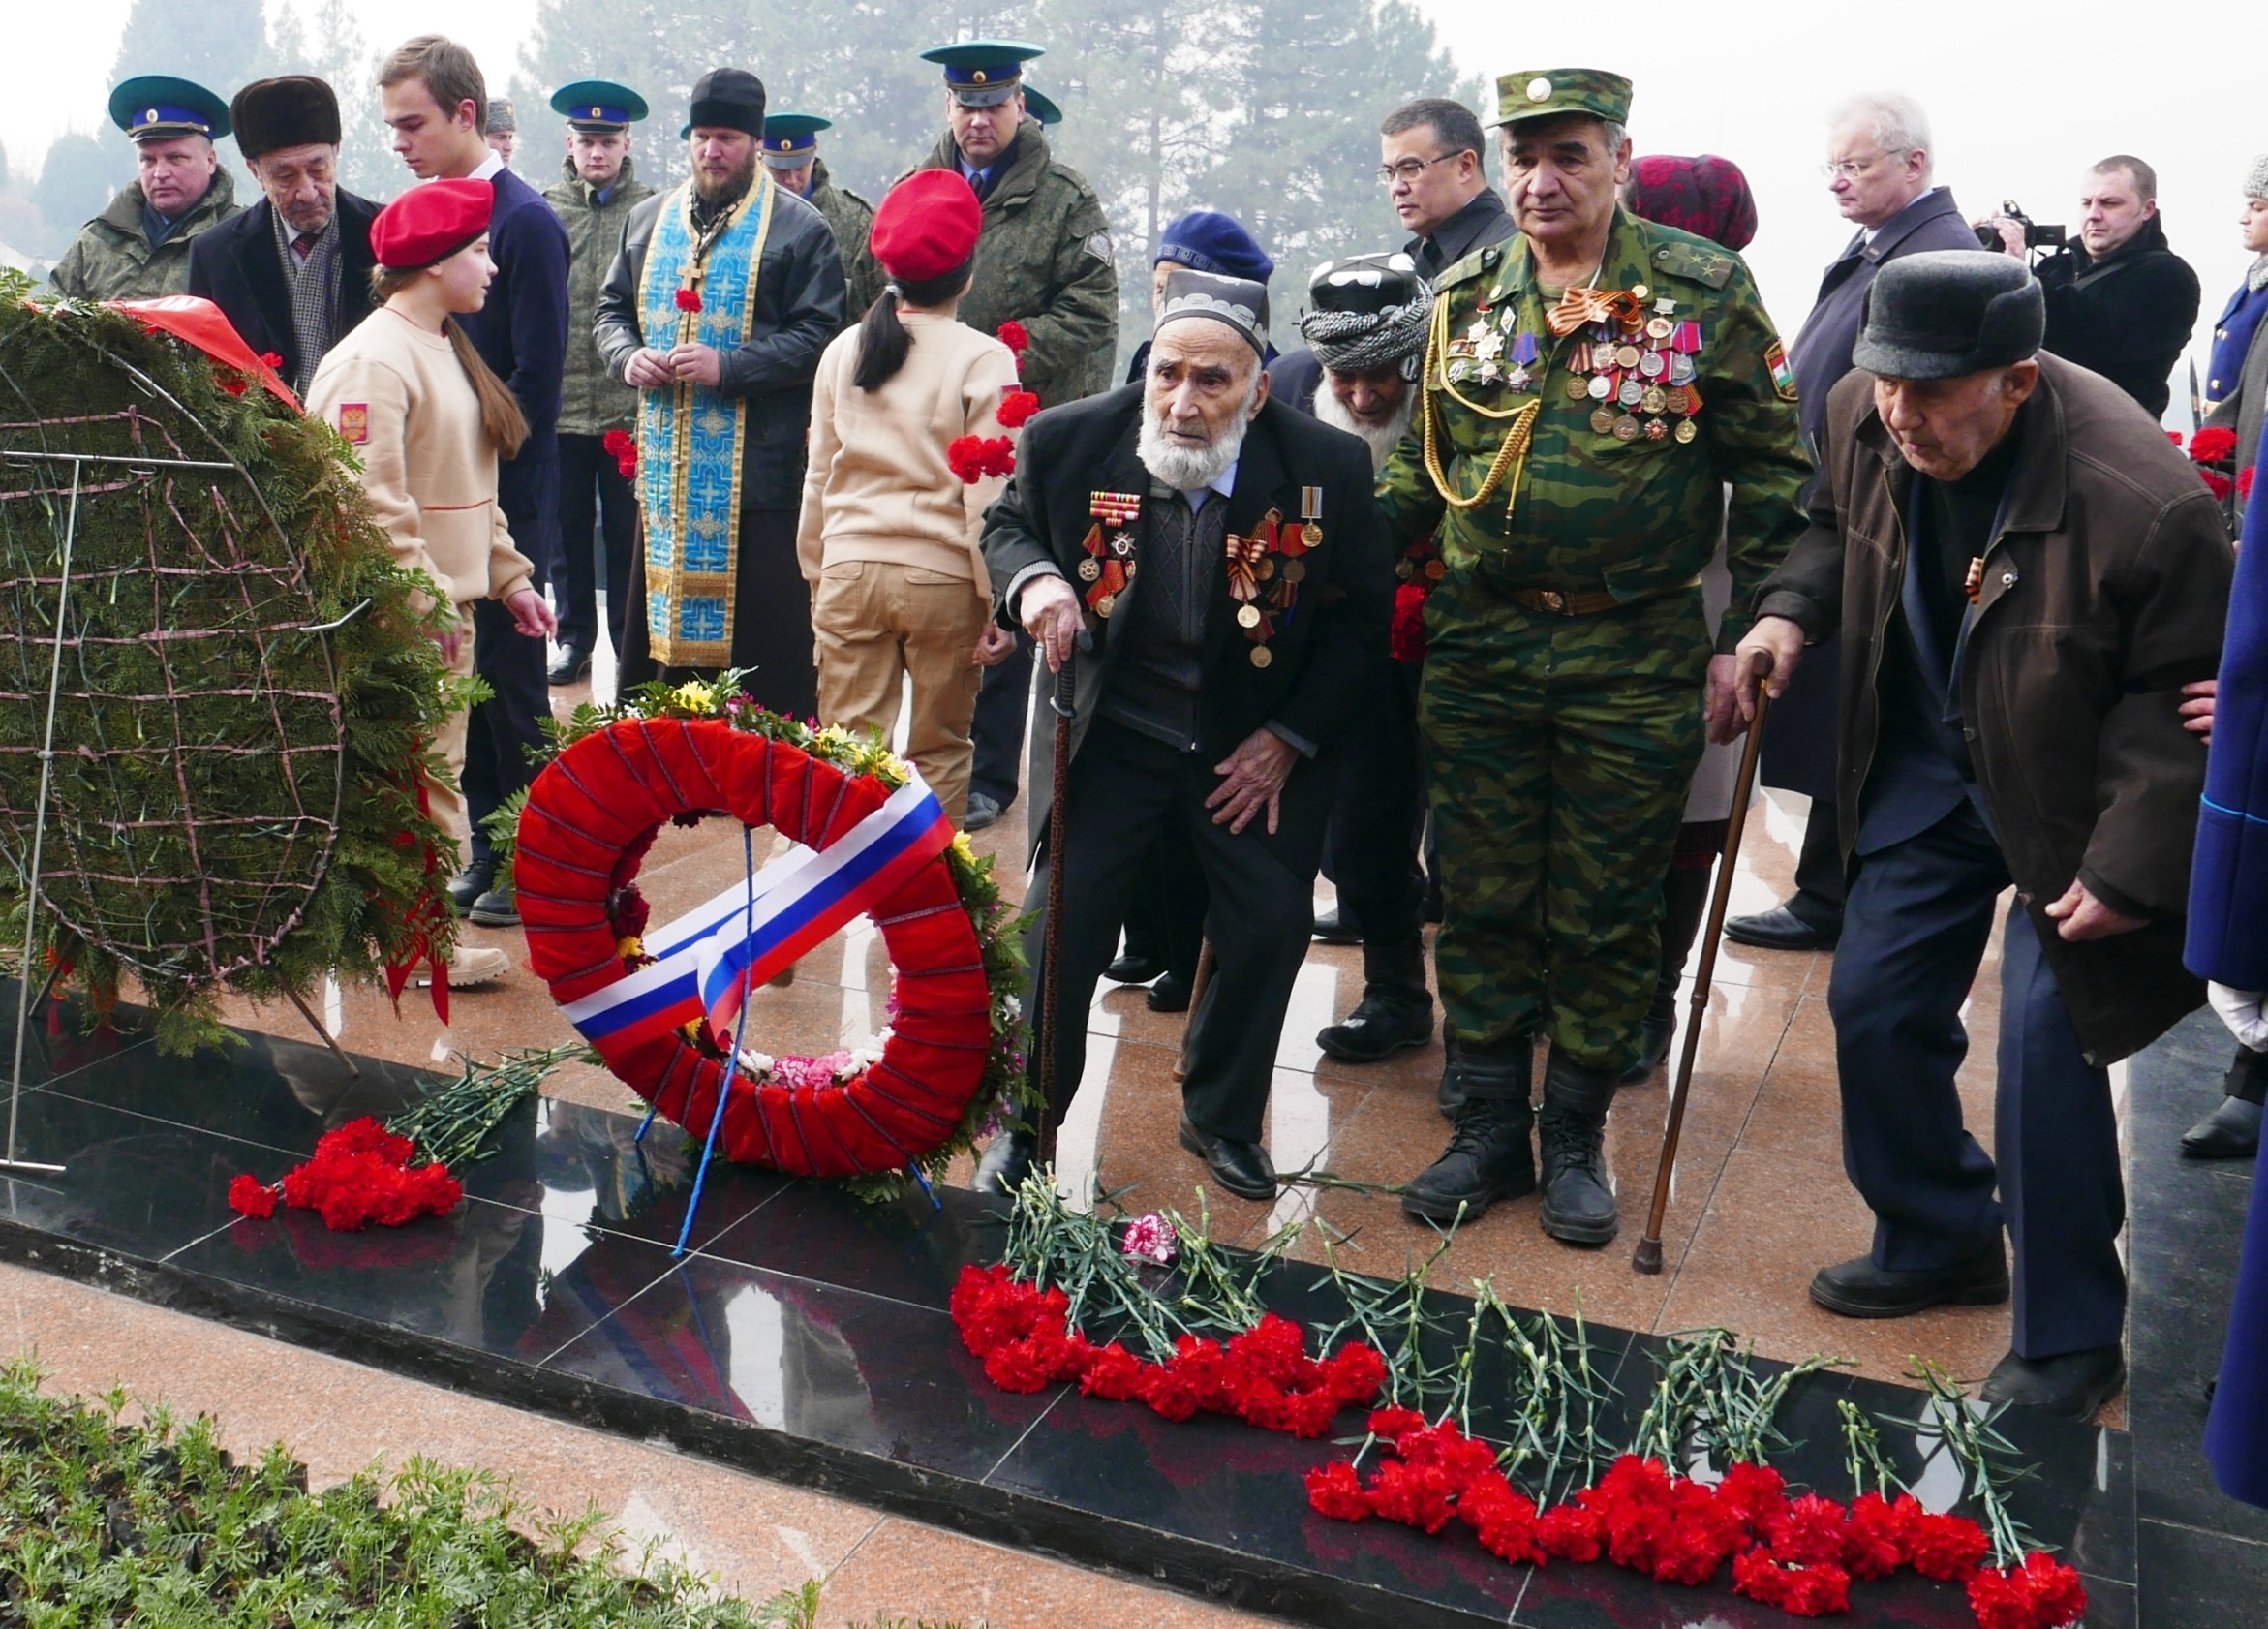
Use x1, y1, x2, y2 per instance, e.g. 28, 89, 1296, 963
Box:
1379, 209, 1812, 651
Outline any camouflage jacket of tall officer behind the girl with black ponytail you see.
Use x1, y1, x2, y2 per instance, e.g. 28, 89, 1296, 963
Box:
914, 118, 1119, 406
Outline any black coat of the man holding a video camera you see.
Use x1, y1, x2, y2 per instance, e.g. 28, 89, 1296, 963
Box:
2038, 216, 2197, 417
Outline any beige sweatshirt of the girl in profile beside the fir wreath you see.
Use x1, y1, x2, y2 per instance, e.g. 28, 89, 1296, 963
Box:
306, 309, 536, 605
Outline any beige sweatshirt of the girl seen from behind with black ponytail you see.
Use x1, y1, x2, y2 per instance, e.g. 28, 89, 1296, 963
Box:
796, 311, 1016, 597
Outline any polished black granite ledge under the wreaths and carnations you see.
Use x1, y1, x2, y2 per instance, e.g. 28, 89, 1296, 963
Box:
0, 985, 2159, 1629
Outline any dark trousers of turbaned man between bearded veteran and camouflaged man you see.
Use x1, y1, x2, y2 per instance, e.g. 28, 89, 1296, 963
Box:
1322, 662, 1426, 996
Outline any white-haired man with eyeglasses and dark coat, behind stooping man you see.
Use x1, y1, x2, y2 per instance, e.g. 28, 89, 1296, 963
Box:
1724, 95, 1977, 951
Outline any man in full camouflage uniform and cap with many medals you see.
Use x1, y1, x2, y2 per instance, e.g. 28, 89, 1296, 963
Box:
1381, 68, 1810, 1245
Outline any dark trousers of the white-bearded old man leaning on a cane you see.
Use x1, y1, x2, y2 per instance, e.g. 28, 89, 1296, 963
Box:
1026, 720, 1332, 1144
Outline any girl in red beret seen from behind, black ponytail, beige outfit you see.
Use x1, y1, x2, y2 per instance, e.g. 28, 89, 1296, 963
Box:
796, 170, 1020, 823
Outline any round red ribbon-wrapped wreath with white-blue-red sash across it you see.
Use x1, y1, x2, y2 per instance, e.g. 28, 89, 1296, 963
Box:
517, 720, 991, 1178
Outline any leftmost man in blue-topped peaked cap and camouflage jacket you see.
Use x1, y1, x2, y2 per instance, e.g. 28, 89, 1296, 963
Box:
50, 73, 240, 299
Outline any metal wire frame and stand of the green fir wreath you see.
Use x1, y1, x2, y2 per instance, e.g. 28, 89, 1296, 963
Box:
0, 343, 360, 1173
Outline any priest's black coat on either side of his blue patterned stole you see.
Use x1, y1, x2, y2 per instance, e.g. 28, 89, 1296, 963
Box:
597, 186, 843, 510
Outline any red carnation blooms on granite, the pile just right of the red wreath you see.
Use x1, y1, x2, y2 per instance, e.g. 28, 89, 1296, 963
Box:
953, 1266, 1378, 1452
